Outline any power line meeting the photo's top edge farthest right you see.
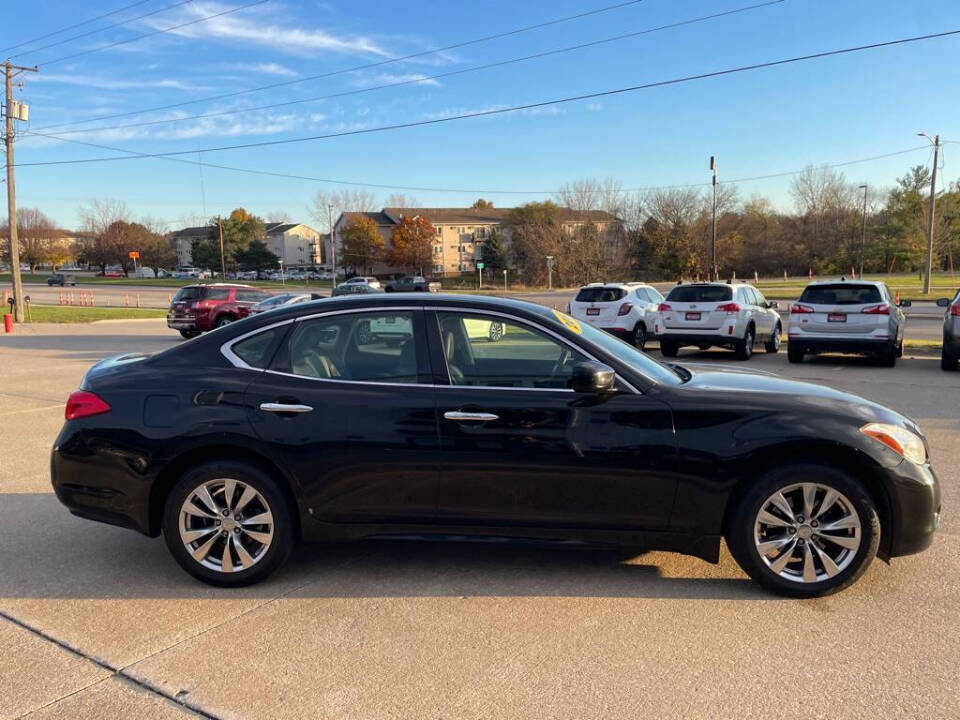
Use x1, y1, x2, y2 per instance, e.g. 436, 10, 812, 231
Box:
41, 0, 786, 135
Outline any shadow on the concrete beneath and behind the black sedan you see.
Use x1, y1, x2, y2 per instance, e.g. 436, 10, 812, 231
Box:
0, 493, 777, 600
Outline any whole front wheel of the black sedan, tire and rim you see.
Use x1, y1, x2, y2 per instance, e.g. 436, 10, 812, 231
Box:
726, 463, 880, 597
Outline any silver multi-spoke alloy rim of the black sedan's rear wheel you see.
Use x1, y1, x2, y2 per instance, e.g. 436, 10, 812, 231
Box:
179, 478, 273, 573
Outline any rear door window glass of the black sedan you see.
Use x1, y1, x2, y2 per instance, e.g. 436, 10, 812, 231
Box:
282, 311, 418, 384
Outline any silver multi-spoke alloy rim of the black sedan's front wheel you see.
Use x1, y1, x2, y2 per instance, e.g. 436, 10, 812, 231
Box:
753, 483, 863, 583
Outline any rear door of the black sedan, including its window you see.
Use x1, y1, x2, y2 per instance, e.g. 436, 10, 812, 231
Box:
246, 308, 439, 523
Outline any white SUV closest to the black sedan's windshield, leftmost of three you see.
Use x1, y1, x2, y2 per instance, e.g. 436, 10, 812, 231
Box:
570, 283, 663, 350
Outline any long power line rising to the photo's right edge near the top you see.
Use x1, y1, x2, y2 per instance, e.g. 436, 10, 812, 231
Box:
18, 30, 960, 167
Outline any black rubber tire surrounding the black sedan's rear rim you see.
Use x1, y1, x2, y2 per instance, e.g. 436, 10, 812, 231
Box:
163, 460, 295, 587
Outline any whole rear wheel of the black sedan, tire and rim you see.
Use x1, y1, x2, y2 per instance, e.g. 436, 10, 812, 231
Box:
163, 461, 294, 587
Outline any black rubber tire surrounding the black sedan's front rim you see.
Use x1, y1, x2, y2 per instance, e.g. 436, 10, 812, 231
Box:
725, 462, 880, 598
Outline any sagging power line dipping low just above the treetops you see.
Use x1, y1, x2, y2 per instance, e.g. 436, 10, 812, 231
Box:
27, 130, 940, 195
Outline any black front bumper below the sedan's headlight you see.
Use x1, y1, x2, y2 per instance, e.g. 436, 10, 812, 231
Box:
883, 460, 941, 557
